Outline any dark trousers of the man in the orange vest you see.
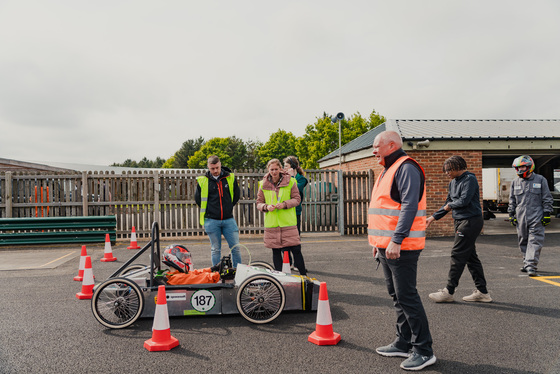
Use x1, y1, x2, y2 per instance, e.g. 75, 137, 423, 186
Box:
379, 249, 433, 356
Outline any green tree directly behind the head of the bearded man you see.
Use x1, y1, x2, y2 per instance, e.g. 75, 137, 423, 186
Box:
189, 136, 247, 169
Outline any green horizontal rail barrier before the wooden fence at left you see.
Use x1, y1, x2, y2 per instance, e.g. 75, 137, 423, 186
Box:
0, 216, 117, 245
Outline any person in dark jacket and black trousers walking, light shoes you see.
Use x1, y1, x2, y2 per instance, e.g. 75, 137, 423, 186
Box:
426, 156, 492, 303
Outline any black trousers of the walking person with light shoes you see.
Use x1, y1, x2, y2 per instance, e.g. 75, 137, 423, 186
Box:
447, 216, 488, 295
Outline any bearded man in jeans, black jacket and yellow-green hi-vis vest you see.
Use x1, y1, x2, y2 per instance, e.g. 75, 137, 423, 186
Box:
194, 156, 241, 267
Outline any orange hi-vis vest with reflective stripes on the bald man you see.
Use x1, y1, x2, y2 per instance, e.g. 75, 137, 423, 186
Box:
368, 156, 426, 250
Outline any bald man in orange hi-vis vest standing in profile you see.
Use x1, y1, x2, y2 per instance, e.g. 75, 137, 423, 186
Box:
368, 131, 436, 370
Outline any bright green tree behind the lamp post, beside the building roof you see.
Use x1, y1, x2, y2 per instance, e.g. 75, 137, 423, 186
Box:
296, 110, 385, 169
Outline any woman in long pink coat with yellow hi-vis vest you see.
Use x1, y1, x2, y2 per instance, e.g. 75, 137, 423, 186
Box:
257, 159, 307, 275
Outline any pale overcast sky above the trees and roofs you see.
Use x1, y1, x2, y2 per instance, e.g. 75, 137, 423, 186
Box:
0, 0, 560, 165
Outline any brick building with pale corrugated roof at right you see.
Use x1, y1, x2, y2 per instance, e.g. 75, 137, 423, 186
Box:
319, 120, 560, 236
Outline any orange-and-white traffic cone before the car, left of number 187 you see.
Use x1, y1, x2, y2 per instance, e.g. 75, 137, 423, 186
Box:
144, 286, 179, 352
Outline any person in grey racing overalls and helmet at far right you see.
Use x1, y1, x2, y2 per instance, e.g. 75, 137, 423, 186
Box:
508, 156, 553, 276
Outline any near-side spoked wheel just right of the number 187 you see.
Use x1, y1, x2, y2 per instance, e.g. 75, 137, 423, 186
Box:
237, 274, 286, 323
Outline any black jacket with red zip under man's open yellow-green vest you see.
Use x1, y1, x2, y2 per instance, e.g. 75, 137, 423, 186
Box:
194, 166, 239, 220
